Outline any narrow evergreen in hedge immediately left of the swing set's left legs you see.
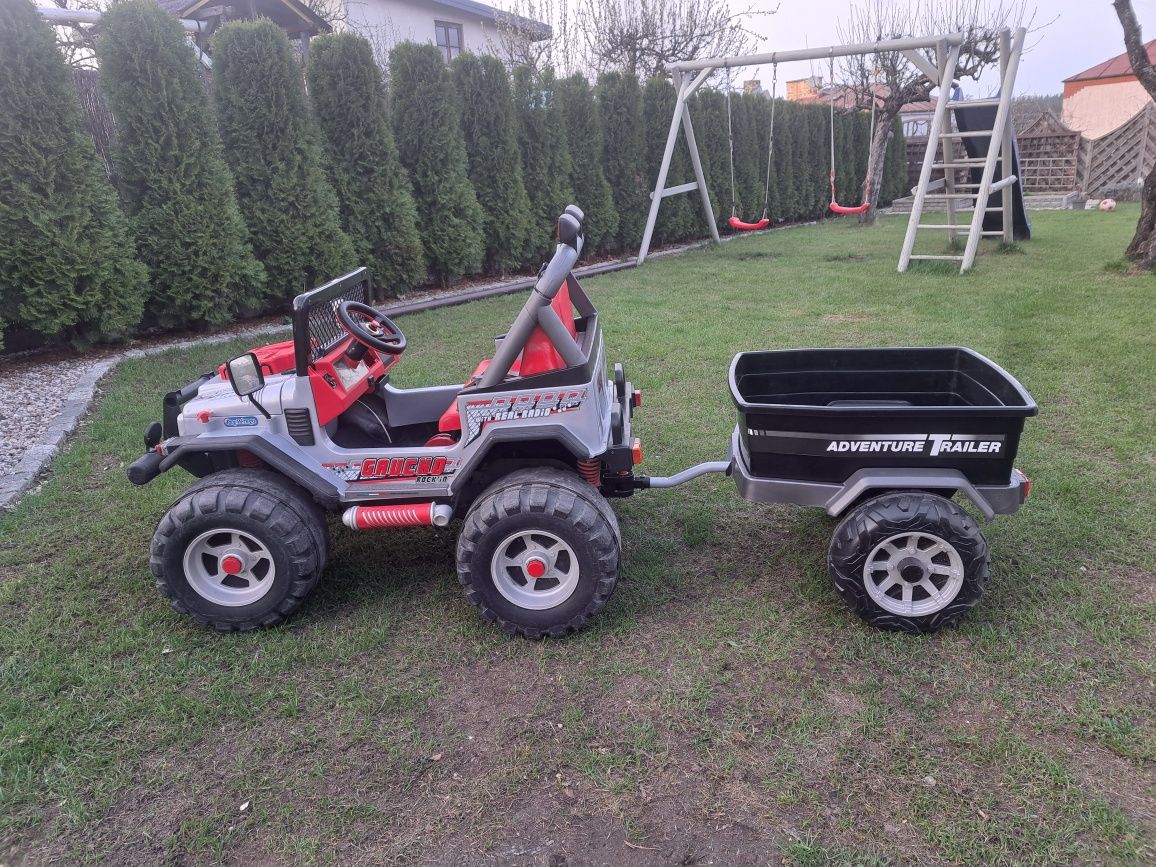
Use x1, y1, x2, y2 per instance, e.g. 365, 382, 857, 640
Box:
596, 72, 649, 251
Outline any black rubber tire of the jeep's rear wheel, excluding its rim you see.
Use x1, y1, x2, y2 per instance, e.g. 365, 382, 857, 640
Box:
458, 468, 622, 639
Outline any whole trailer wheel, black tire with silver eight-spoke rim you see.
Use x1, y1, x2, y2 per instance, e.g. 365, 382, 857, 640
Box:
827, 491, 988, 632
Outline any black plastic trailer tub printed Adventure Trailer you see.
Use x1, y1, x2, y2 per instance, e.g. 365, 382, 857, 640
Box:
731, 347, 1037, 486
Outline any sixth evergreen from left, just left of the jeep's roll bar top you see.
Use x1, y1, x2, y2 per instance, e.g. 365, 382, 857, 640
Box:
453, 54, 531, 274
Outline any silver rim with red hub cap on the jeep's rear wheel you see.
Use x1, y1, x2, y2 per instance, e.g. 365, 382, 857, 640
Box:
490, 529, 578, 610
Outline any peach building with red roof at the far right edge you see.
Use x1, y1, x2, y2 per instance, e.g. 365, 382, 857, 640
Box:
1060, 39, 1156, 139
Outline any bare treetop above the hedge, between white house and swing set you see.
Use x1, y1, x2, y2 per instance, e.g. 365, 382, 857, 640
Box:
573, 0, 773, 79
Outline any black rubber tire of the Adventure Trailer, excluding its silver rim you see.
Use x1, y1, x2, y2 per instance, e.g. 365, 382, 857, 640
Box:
827, 491, 988, 633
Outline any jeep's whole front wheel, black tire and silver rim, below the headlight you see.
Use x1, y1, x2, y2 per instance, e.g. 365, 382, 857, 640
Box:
149, 469, 327, 632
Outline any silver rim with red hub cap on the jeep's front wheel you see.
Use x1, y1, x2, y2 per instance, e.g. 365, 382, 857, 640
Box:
184, 527, 276, 608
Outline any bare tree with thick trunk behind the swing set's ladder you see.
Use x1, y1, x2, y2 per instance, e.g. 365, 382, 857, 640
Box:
838, 0, 1029, 223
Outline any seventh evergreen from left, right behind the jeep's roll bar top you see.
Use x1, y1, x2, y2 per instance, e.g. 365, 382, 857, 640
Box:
513, 66, 575, 262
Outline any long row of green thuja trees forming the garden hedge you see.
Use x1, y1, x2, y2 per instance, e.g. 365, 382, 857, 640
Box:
0, 22, 906, 349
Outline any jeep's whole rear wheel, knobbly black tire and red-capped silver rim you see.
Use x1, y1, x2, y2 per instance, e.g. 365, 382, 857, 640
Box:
458, 468, 622, 639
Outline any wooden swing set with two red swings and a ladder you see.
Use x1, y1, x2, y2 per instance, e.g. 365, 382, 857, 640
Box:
637, 28, 1027, 271
